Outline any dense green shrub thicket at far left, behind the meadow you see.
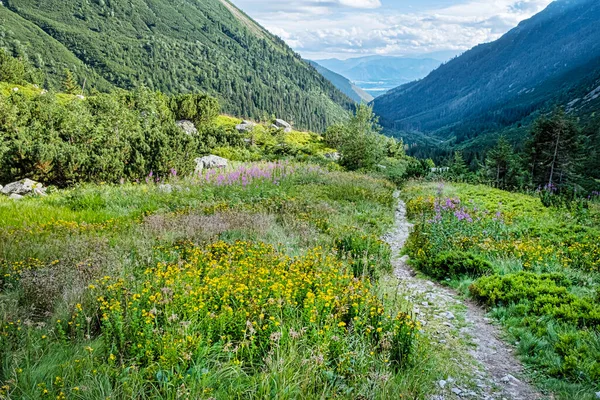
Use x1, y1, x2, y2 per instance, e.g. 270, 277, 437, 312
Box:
0, 89, 199, 186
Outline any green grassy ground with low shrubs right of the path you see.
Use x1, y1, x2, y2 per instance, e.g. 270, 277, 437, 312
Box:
403, 182, 600, 400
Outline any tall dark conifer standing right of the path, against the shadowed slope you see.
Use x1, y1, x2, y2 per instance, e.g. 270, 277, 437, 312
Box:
528, 108, 583, 187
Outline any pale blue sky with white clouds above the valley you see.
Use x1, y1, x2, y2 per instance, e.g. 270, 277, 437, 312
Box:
233, 0, 552, 61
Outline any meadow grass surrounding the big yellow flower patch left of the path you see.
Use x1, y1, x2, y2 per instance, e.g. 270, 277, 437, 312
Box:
0, 166, 468, 399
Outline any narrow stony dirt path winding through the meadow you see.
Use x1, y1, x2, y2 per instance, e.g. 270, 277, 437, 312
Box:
385, 195, 544, 400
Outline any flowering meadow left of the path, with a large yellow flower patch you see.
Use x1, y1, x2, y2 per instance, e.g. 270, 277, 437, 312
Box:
0, 163, 459, 399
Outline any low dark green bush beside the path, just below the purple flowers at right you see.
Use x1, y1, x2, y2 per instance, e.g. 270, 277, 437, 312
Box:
420, 251, 493, 279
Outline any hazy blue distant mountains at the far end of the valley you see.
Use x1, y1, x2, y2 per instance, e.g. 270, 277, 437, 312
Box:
316, 56, 441, 97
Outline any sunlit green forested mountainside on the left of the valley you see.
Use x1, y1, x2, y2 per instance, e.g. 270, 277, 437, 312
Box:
0, 0, 353, 131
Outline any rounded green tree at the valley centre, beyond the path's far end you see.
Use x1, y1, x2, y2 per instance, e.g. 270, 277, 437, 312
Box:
325, 104, 386, 171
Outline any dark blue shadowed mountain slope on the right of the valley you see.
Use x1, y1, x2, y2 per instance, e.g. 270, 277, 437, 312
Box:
374, 0, 600, 143
